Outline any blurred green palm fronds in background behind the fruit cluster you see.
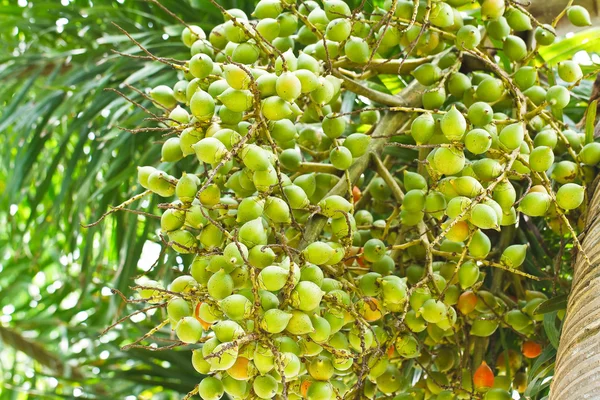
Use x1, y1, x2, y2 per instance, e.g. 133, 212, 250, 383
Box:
0, 0, 600, 399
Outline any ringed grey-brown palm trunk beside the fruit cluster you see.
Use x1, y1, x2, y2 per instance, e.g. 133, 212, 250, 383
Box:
550, 180, 600, 400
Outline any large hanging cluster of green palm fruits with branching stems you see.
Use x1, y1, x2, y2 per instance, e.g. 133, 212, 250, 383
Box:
110, 0, 600, 400
